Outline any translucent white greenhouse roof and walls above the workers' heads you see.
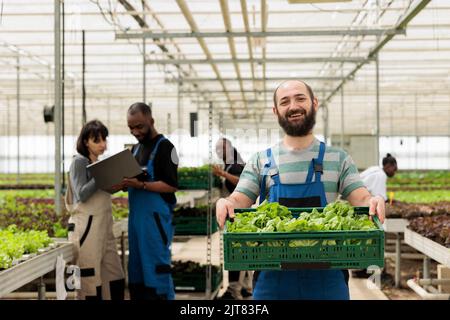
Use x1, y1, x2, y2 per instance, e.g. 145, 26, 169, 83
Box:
0, 0, 450, 136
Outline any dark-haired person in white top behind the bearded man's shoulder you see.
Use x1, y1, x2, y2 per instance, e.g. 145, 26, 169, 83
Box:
360, 153, 398, 201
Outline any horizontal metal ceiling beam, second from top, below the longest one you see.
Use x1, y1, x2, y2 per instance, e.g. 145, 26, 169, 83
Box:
145, 57, 373, 64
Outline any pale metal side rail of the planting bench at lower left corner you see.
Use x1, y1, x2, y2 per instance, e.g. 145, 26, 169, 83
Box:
0, 242, 73, 299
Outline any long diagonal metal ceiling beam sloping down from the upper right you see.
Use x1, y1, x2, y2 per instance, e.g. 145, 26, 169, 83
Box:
324, 0, 431, 104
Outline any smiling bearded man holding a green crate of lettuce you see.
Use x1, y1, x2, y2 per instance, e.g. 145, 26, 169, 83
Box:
216, 80, 385, 300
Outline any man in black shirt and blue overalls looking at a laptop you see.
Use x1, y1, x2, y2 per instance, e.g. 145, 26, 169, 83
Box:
122, 102, 178, 300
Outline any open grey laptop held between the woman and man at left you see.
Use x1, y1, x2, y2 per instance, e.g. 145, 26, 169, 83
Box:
86, 149, 143, 191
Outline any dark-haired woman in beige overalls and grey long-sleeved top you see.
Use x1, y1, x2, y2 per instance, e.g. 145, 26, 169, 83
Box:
65, 120, 125, 300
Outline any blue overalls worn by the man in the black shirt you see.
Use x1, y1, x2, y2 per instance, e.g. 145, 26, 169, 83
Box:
128, 136, 175, 300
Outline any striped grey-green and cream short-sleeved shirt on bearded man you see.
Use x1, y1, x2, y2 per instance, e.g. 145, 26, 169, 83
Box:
235, 138, 364, 203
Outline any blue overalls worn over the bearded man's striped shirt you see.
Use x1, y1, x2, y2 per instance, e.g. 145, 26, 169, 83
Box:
253, 142, 349, 300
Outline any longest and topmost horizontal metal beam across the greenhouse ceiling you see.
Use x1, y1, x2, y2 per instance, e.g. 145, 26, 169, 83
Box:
116, 28, 406, 39
